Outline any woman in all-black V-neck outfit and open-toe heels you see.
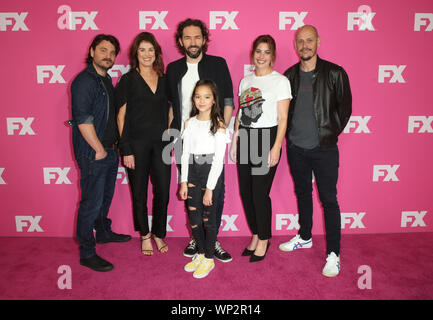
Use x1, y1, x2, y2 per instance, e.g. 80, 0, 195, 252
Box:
116, 32, 171, 256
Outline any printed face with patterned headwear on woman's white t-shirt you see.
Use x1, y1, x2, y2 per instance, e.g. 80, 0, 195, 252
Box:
239, 87, 265, 127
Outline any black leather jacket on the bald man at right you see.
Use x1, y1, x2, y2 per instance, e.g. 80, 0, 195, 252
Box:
284, 57, 352, 147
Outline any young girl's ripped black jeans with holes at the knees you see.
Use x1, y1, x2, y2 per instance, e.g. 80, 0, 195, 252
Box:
186, 154, 222, 259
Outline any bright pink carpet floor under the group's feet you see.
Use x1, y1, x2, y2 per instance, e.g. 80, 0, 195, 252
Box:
0, 233, 433, 300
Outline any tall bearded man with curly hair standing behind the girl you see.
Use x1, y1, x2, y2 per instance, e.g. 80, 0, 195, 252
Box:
166, 19, 234, 262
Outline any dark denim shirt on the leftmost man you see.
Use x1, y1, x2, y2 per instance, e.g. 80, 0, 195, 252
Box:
71, 64, 111, 160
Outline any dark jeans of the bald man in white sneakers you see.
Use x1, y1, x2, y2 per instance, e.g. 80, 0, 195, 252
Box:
287, 144, 341, 255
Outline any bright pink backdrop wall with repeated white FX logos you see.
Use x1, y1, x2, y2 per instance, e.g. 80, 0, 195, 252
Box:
0, 0, 433, 237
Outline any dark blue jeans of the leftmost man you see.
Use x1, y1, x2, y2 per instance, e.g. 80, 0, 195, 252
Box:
77, 148, 119, 259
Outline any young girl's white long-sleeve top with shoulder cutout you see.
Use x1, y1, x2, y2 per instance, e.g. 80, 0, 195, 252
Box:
180, 117, 231, 190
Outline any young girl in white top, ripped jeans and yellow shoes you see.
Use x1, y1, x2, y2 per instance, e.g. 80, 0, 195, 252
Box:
179, 79, 230, 278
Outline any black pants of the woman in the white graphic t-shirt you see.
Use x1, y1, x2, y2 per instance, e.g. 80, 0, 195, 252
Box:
237, 126, 277, 240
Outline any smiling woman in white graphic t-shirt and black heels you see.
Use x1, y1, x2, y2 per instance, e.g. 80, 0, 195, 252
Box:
230, 35, 292, 262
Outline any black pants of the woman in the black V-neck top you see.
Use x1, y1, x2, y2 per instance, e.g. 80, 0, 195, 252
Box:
128, 140, 171, 238
